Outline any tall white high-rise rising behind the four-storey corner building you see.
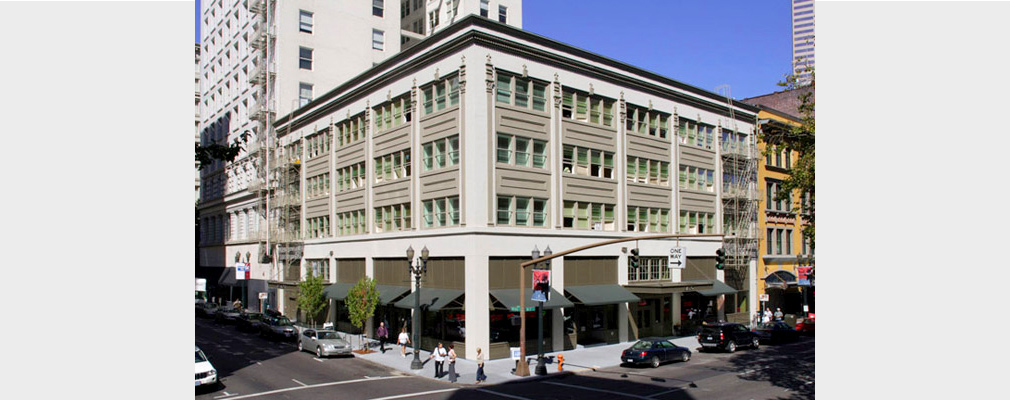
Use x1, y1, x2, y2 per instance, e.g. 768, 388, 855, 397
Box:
197, 0, 522, 307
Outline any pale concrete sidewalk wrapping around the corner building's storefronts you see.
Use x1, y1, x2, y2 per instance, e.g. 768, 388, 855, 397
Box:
327, 332, 699, 386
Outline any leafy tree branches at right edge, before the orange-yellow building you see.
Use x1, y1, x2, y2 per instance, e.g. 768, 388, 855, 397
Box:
762, 66, 815, 248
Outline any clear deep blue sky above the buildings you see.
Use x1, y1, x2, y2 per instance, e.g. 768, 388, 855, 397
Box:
196, 0, 792, 99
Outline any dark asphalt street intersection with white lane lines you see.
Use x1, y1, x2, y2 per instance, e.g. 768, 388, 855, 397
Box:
196, 319, 814, 400
